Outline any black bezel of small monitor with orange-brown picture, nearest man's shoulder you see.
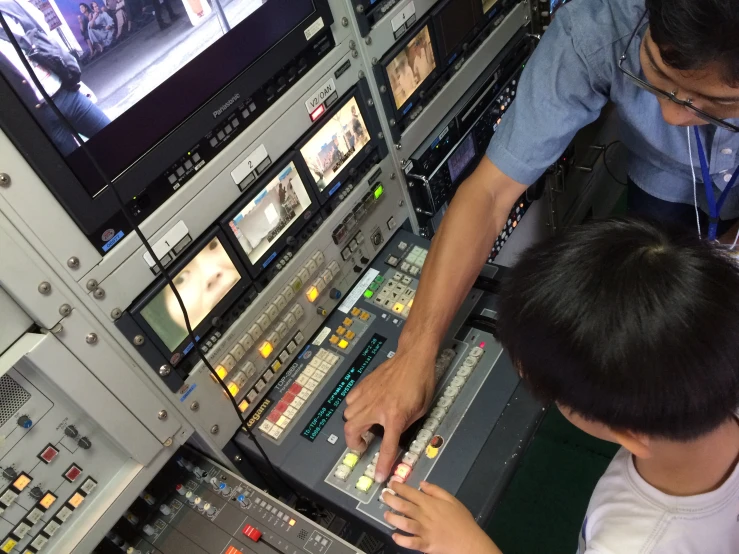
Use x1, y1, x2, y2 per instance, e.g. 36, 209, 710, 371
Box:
374, 15, 443, 124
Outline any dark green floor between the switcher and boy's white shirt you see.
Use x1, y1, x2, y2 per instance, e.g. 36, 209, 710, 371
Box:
486, 408, 618, 554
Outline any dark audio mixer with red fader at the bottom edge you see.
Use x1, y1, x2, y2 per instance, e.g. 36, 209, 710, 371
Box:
95, 447, 357, 554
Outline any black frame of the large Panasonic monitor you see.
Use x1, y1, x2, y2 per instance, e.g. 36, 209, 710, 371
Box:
0, 0, 334, 247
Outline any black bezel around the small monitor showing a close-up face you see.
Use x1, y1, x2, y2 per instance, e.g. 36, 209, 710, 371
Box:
128, 227, 252, 367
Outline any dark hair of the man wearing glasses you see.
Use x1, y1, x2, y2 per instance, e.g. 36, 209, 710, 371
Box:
646, 0, 739, 86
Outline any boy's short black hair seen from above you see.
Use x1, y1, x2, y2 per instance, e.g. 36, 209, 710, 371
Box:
498, 218, 739, 441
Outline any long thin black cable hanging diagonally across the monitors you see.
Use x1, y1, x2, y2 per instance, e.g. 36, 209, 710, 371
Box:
0, 13, 300, 497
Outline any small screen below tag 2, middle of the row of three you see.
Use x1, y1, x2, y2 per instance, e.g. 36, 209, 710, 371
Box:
229, 162, 311, 265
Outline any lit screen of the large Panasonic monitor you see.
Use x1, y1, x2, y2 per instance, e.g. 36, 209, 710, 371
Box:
0, 0, 315, 192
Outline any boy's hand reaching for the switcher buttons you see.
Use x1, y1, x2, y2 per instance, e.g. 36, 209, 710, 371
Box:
383, 481, 502, 554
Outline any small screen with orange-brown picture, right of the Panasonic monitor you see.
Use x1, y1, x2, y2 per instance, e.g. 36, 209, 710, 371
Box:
386, 25, 436, 109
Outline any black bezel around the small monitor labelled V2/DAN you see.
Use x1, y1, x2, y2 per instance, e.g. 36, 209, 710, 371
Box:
294, 84, 384, 206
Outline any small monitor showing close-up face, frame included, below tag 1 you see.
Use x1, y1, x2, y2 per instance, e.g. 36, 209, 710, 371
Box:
131, 231, 251, 365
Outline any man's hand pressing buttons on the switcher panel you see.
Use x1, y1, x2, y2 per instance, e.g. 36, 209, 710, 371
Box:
344, 351, 436, 483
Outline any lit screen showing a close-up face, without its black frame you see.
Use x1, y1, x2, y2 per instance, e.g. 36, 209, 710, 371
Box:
141, 237, 241, 351
